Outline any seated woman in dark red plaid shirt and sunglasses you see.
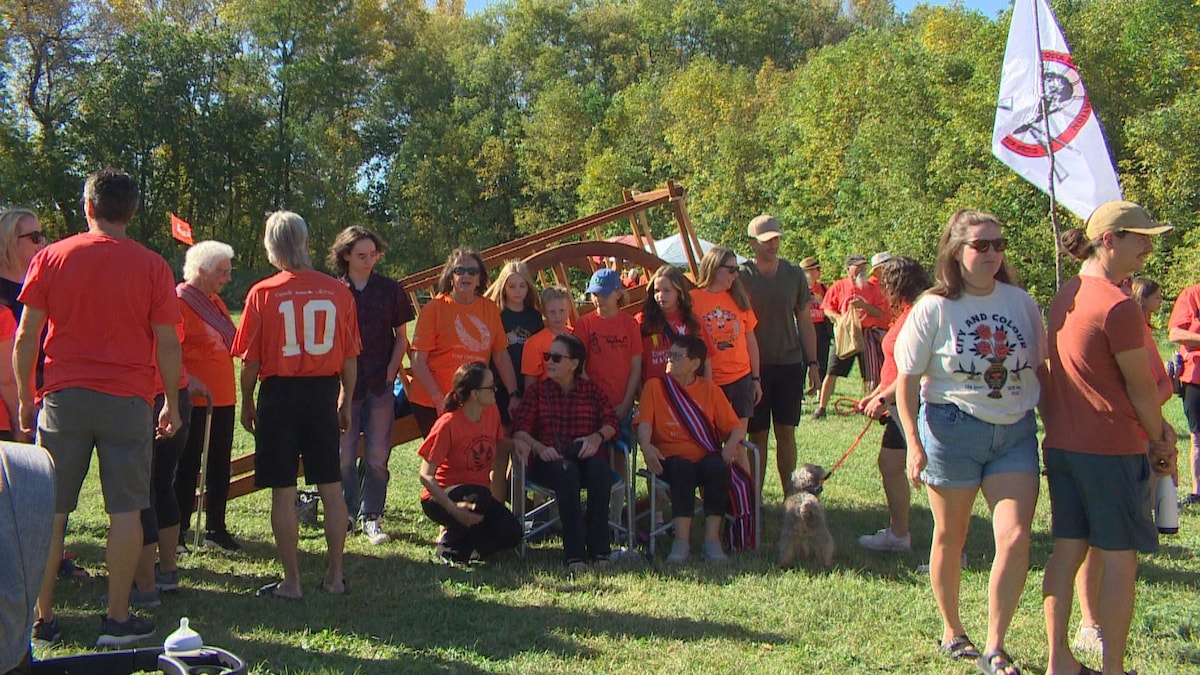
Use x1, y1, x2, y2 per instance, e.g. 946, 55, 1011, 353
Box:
512, 334, 617, 572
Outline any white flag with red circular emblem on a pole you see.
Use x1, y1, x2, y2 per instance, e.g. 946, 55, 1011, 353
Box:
991, 0, 1121, 221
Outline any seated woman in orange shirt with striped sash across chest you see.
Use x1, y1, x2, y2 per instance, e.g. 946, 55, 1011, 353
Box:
637, 334, 745, 563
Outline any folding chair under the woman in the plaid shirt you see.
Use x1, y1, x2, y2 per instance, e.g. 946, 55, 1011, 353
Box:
511, 438, 636, 557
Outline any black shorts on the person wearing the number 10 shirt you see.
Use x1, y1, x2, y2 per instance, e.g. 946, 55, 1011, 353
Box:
254, 375, 342, 488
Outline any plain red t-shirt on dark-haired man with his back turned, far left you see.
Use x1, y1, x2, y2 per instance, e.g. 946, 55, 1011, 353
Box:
20, 232, 181, 405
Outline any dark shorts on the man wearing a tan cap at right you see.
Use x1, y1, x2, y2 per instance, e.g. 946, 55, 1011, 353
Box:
1045, 448, 1158, 554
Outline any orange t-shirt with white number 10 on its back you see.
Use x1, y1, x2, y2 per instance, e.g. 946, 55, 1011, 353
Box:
230, 270, 362, 381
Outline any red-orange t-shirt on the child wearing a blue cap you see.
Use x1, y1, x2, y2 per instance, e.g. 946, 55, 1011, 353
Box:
575, 312, 642, 407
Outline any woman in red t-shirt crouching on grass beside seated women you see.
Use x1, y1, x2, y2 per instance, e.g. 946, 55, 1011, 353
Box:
416, 362, 523, 563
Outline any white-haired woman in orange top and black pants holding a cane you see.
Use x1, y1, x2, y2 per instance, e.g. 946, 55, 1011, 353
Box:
168, 241, 241, 552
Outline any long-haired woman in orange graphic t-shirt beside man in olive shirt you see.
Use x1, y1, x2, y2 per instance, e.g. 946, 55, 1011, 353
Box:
691, 246, 762, 430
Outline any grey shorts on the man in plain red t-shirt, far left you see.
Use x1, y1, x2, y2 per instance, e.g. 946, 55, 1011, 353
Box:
37, 388, 155, 513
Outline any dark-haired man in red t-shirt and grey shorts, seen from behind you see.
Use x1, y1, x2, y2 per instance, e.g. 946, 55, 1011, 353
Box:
12, 168, 181, 646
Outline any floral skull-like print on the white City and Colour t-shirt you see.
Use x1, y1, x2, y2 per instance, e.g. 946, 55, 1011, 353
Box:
954, 312, 1033, 399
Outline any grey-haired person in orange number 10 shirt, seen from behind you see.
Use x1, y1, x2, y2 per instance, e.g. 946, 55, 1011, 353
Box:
232, 211, 361, 599
